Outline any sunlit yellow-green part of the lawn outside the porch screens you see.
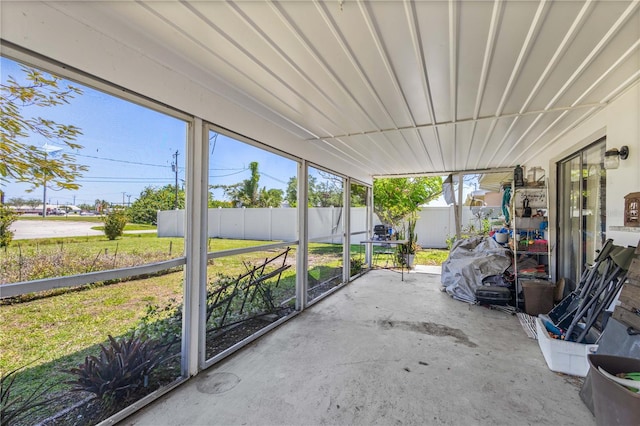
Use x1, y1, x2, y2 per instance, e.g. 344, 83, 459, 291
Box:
0, 234, 448, 371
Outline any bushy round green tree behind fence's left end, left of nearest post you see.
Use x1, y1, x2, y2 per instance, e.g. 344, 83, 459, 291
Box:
128, 185, 185, 225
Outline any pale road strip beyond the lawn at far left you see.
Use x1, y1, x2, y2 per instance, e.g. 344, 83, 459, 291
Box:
11, 220, 156, 240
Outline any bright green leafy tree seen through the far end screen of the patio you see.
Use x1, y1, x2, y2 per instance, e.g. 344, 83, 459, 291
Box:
373, 176, 442, 229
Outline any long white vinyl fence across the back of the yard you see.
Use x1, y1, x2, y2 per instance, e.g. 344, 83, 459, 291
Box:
158, 206, 500, 248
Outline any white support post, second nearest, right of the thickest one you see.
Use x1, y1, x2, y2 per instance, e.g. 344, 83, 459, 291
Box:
296, 160, 309, 311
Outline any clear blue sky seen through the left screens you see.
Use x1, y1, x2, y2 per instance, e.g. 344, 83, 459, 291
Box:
0, 58, 296, 205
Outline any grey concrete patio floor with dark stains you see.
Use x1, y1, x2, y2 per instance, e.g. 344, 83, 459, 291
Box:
122, 270, 595, 426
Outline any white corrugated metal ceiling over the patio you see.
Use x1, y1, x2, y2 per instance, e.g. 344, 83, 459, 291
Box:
2, 0, 640, 180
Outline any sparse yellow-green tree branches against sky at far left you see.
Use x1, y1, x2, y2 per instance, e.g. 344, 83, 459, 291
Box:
0, 66, 87, 189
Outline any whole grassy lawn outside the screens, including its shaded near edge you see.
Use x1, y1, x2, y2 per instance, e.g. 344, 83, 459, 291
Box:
0, 234, 448, 416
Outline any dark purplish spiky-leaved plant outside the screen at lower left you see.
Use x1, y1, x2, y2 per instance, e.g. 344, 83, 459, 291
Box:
68, 333, 166, 405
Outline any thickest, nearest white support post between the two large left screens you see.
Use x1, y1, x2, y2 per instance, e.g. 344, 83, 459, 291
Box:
182, 118, 209, 376
